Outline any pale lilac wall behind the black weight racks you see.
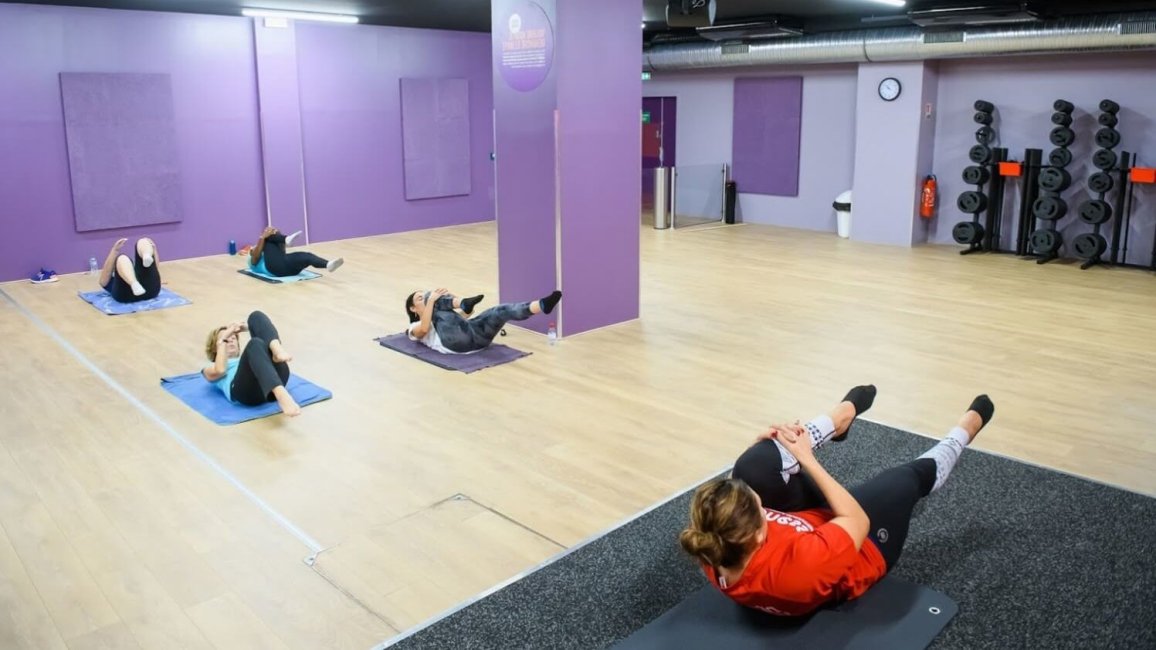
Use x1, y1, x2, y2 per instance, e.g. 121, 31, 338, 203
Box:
931, 52, 1156, 264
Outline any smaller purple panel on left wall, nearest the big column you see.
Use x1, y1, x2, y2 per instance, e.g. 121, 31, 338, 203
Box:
401, 79, 470, 201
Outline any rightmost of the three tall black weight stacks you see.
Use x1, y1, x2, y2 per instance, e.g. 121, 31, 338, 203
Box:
1072, 99, 1132, 271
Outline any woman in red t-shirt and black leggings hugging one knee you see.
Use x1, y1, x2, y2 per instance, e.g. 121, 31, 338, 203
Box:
679, 386, 995, 616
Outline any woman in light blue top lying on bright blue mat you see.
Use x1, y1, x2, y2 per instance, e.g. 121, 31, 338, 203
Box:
201, 311, 301, 418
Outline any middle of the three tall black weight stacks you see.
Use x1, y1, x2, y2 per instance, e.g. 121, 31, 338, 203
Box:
1030, 99, 1076, 264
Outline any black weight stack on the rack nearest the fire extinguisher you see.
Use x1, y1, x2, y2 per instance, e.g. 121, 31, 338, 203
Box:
951, 99, 1007, 254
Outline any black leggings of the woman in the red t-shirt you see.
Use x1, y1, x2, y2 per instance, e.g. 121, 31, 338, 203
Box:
732, 441, 935, 570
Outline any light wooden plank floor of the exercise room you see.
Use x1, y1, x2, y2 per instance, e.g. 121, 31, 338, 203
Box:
0, 224, 1156, 650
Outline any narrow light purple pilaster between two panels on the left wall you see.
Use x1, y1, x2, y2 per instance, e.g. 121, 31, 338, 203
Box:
253, 19, 309, 243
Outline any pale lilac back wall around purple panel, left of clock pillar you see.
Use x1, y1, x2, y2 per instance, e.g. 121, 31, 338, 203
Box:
643, 65, 857, 232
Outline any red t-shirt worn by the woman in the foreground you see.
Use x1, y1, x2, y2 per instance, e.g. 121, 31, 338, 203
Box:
703, 508, 887, 616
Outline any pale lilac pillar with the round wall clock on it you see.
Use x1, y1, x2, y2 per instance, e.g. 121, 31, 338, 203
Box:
851, 61, 929, 245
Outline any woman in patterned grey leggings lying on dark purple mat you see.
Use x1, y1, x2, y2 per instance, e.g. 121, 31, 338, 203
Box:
406, 289, 562, 354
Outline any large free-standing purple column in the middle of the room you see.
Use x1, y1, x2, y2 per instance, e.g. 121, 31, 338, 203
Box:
491, 0, 642, 334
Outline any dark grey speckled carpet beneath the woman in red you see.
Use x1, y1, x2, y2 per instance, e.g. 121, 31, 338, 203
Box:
387, 420, 1156, 650
